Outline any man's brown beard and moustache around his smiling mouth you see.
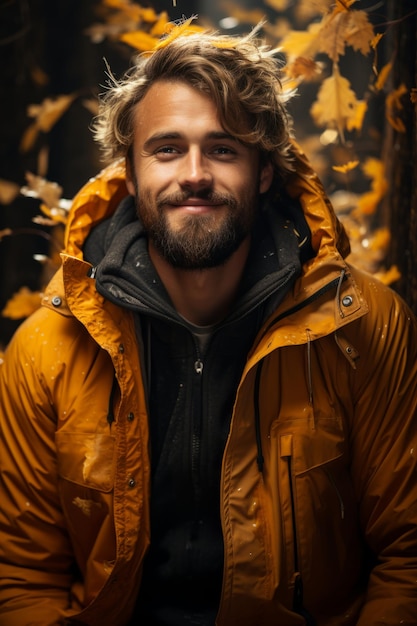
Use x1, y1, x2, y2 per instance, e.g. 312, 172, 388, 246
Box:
136, 187, 257, 270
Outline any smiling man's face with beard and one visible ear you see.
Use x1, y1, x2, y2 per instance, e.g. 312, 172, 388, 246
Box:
127, 81, 272, 269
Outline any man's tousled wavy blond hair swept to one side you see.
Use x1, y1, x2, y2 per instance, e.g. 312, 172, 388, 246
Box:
93, 26, 293, 177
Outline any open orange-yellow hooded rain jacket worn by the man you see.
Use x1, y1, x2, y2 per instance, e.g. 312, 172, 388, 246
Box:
0, 149, 417, 626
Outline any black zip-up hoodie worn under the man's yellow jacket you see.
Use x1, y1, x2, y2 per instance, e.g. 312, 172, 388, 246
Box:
84, 196, 308, 626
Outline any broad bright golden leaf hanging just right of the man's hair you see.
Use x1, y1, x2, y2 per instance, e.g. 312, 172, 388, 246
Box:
310, 66, 358, 137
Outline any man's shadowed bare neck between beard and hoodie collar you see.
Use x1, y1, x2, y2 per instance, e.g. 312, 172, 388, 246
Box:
149, 238, 250, 326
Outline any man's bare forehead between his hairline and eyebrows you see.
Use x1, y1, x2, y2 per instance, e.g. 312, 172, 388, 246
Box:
135, 80, 222, 136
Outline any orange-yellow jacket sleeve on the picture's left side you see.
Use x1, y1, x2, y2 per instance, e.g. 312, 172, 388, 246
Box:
0, 313, 73, 626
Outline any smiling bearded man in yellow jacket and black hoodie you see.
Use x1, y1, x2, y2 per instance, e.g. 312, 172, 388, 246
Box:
0, 20, 417, 626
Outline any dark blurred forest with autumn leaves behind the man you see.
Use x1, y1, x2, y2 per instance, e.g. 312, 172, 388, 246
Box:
0, 0, 417, 352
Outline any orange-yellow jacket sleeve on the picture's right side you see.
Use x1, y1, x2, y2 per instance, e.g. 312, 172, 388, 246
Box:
351, 280, 417, 626
